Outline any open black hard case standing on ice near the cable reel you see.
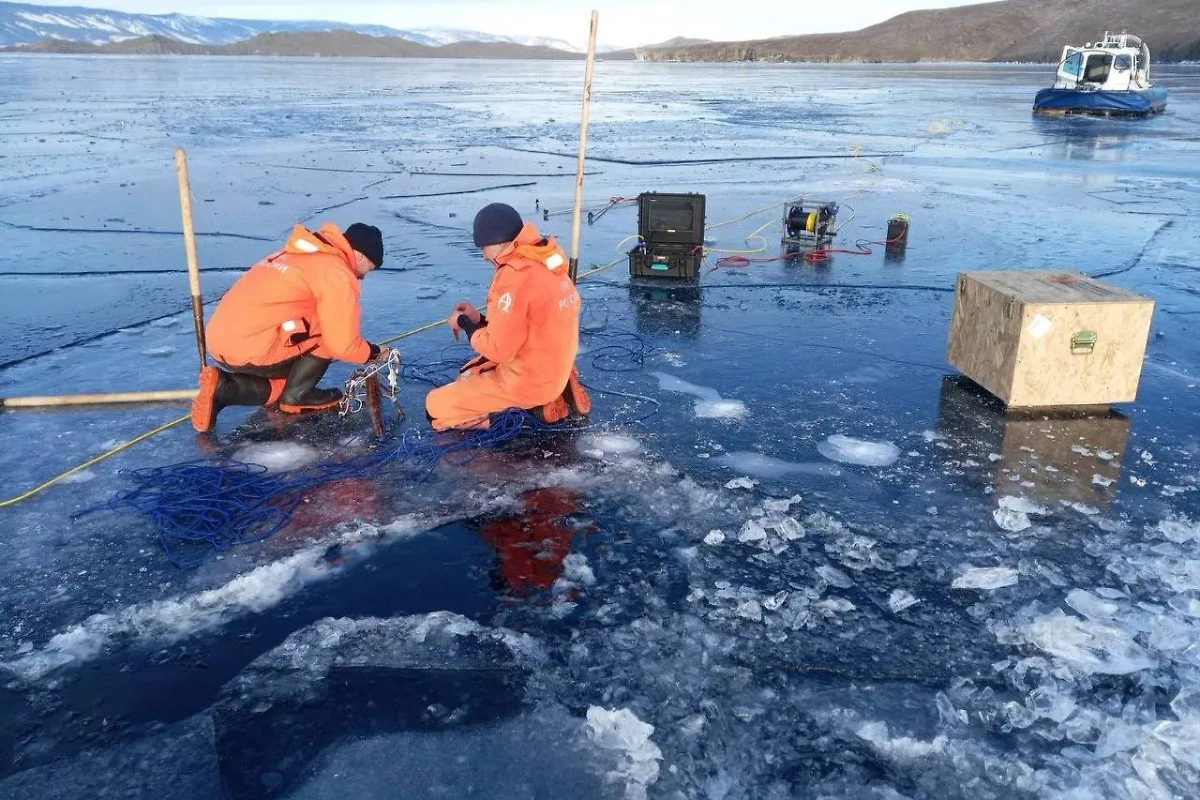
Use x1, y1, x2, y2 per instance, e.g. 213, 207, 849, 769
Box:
629, 192, 704, 281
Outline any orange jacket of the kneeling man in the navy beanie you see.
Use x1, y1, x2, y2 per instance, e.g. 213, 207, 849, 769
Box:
470, 222, 580, 408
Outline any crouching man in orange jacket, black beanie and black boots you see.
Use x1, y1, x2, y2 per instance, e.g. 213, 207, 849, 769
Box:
192, 223, 390, 433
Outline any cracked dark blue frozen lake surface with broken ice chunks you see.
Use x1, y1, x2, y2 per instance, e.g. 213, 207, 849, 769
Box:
0, 56, 1200, 800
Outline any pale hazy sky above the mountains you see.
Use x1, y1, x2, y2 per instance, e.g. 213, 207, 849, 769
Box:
29, 0, 980, 46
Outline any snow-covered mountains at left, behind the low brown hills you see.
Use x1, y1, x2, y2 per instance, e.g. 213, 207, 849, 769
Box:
0, 2, 584, 53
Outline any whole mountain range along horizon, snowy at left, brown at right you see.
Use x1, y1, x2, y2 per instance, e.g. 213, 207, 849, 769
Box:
0, 0, 1200, 64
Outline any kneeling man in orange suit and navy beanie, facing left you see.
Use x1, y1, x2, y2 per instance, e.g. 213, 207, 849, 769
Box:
425, 203, 590, 431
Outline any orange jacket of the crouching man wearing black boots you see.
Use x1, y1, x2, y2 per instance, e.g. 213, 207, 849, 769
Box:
205, 223, 371, 367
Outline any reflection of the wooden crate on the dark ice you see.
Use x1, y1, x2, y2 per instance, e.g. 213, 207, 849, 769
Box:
938, 377, 1129, 509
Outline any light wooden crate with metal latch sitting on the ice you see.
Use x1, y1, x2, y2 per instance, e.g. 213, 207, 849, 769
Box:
946, 270, 1154, 408
